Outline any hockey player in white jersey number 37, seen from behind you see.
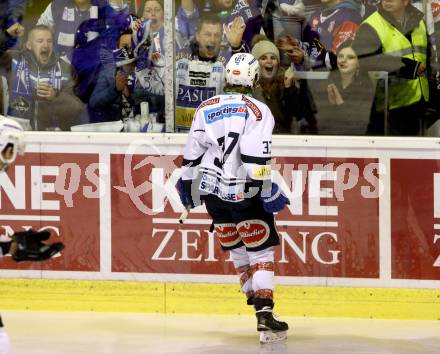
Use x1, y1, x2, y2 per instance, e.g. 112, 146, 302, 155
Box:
177, 53, 289, 343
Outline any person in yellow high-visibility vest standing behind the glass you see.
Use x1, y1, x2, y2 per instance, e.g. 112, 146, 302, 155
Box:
353, 0, 430, 135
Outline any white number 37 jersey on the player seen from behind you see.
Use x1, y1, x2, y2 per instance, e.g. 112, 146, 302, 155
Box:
182, 94, 274, 202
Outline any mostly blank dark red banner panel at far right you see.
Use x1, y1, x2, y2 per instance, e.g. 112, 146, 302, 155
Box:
391, 159, 440, 280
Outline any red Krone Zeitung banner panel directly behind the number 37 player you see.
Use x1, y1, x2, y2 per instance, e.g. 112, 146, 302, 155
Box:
111, 154, 379, 278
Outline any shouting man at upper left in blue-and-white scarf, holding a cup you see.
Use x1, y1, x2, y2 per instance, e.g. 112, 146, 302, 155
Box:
8, 25, 83, 130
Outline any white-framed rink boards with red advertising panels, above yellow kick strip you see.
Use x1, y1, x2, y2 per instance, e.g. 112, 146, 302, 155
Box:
0, 133, 440, 288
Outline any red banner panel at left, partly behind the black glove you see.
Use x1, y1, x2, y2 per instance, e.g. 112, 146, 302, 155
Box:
0, 153, 100, 271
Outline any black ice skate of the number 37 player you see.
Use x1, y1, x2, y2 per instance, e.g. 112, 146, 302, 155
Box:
255, 299, 289, 343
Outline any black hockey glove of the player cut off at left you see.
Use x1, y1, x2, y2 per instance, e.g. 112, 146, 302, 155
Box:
9, 229, 64, 262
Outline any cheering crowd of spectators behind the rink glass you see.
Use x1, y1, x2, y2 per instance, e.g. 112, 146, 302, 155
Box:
0, 0, 440, 136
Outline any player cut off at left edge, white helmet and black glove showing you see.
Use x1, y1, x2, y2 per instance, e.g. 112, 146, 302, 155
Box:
0, 115, 64, 354
